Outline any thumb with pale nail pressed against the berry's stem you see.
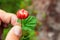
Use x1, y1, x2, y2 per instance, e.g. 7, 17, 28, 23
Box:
5, 25, 22, 40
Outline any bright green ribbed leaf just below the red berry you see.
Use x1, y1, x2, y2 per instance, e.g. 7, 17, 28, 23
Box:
22, 16, 37, 30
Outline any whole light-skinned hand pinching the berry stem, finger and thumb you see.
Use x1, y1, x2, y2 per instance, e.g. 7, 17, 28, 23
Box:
0, 10, 22, 40
